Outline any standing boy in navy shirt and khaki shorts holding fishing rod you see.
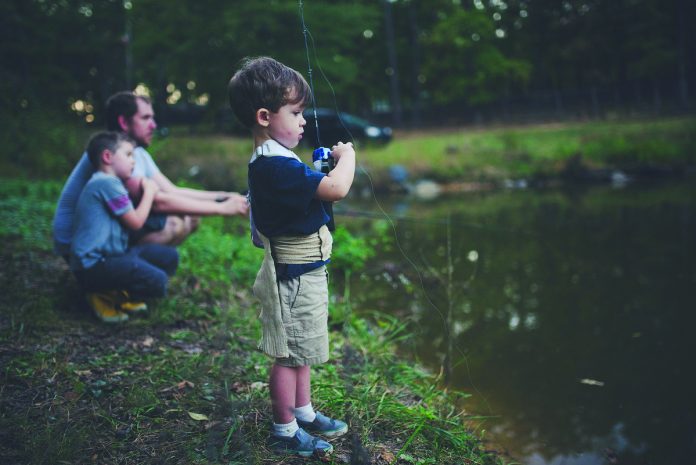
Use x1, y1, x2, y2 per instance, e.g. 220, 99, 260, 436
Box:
229, 57, 355, 456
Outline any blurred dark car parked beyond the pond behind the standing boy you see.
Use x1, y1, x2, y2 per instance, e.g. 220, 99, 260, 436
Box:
303, 108, 392, 147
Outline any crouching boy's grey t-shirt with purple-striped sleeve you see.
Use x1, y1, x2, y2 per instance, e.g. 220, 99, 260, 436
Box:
70, 171, 133, 271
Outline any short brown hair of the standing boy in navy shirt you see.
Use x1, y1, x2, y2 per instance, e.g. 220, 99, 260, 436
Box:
227, 57, 312, 129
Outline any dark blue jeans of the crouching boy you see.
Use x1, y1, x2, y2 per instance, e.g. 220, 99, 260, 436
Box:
75, 244, 179, 299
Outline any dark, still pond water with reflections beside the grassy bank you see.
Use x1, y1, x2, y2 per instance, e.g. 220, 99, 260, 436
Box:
336, 182, 696, 465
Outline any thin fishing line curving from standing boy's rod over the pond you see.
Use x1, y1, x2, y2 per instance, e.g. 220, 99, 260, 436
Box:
298, 0, 492, 440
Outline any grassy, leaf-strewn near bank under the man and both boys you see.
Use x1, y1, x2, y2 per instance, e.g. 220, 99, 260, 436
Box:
0, 179, 503, 465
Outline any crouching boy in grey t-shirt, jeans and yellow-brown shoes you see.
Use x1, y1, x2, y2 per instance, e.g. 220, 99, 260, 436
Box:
70, 132, 179, 323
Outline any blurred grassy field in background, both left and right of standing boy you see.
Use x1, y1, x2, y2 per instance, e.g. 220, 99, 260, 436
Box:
153, 117, 696, 189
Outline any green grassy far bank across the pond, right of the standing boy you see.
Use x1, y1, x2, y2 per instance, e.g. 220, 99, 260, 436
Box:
360, 117, 696, 182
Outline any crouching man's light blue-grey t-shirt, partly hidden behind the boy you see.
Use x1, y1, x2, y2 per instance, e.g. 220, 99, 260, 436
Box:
53, 147, 160, 255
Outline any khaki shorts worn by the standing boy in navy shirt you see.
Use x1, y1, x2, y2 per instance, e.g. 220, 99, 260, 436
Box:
275, 266, 329, 367
